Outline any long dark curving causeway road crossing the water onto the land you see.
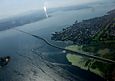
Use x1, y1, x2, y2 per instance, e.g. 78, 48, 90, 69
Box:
16, 29, 115, 64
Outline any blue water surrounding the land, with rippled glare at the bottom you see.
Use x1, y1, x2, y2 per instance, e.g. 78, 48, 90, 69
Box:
0, 3, 115, 81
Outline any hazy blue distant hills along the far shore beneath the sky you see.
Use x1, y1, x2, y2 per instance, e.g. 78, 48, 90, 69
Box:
0, 5, 91, 31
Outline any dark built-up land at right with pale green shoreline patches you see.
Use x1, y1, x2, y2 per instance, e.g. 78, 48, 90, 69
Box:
51, 10, 115, 81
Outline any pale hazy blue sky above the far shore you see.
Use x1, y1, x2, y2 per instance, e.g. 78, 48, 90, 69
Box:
0, 0, 105, 19
